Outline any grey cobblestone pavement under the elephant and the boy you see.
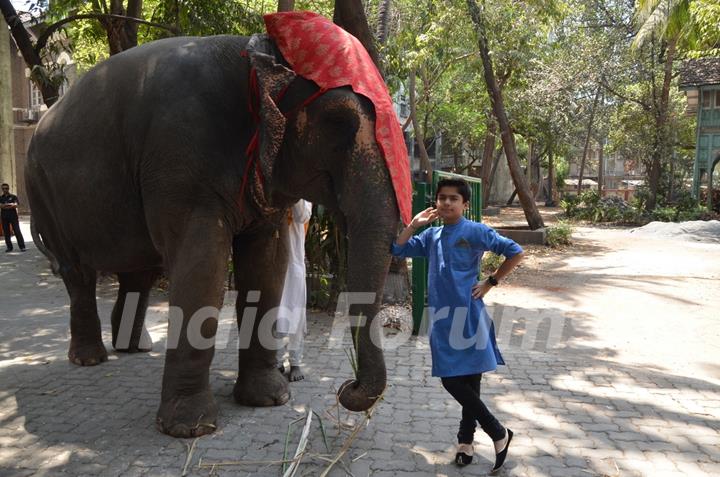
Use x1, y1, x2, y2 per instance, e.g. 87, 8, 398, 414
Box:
0, 220, 720, 477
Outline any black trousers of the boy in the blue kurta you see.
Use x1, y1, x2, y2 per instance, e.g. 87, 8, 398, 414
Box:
441, 374, 505, 444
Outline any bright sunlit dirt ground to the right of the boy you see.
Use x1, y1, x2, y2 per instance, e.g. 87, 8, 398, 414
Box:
485, 208, 720, 382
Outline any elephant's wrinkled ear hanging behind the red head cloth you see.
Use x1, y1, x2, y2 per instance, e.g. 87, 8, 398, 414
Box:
247, 35, 296, 212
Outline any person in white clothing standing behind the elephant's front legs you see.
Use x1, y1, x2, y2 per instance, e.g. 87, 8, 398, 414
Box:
276, 199, 312, 381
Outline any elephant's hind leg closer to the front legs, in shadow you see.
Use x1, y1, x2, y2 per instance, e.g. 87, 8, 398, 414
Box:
111, 270, 159, 353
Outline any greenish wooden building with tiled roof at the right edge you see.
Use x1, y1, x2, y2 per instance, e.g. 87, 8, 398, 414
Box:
679, 58, 720, 209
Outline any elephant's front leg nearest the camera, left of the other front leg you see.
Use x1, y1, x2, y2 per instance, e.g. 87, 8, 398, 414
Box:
157, 217, 230, 437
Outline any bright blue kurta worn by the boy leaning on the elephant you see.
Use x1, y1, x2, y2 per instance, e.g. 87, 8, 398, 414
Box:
392, 217, 522, 378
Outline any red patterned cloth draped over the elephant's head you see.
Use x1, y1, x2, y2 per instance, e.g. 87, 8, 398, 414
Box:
265, 12, 412, 224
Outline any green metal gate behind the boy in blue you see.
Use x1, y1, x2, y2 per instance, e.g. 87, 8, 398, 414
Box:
412, 171, 482, 334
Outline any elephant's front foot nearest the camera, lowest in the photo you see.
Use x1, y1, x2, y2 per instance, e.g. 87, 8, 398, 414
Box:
155, 390, 217, 437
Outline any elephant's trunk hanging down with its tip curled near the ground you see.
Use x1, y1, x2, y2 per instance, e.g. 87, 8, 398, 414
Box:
338, 165, 398, 411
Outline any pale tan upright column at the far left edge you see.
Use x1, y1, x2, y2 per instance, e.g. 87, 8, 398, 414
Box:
0, 13, 17, 190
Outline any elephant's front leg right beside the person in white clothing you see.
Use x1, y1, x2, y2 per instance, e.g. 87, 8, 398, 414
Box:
233, 227, 290, 406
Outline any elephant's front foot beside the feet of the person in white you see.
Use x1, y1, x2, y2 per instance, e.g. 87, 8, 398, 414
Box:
238, 367, 290, 407
